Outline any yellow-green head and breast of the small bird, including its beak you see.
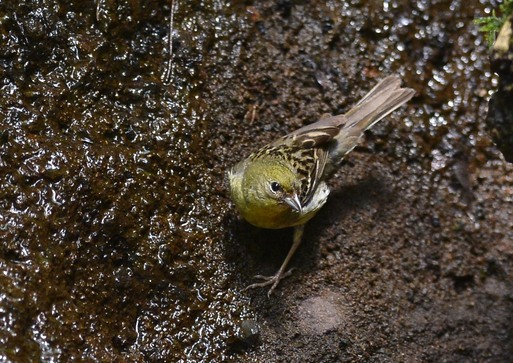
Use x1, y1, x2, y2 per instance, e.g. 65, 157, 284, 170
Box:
230, 158, 304, 228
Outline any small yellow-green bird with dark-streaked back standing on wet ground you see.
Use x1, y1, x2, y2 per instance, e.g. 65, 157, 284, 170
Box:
228, 75, 415, 296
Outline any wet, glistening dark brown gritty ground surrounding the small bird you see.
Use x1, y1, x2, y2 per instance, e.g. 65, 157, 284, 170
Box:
0, 0, 513, 362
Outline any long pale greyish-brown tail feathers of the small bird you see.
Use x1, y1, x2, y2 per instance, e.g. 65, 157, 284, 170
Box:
330, 75, 415, 161
